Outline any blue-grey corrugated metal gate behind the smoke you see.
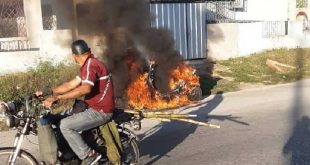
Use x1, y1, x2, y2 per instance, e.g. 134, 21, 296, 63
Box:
150, 3, 206, 60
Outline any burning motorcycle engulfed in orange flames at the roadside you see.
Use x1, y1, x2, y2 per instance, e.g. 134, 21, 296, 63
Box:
127, 62, 202, 110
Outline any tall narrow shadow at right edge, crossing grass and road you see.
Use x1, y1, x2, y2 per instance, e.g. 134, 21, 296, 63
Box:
282, 49, 310, 165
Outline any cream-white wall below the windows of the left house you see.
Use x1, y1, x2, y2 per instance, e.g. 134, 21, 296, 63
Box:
0, 30, 72, 75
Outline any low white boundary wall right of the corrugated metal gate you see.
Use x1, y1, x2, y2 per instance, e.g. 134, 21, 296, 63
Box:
207, 21, 310, 60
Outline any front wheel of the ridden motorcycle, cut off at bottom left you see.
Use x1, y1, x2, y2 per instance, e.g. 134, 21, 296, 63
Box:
0, 147, 39, 165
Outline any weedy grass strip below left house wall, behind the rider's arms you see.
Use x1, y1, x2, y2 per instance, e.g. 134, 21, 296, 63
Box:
0, 62, 78, 101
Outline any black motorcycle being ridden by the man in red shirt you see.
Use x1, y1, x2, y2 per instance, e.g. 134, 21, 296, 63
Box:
0, 96, 141, 165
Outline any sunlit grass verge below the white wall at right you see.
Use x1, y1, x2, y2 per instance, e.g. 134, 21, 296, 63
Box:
201, 48, 310, 93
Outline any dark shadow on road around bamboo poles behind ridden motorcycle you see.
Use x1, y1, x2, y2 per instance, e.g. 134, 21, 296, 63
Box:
140, 92, 248, 164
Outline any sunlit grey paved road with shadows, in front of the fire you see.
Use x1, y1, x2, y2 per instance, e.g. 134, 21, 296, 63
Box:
0, 80, 310, 165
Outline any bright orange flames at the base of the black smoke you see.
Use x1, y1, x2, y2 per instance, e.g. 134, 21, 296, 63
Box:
127, 64, 199, 110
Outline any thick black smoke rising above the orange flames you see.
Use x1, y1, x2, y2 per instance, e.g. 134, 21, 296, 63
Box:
72, 0, 182, 97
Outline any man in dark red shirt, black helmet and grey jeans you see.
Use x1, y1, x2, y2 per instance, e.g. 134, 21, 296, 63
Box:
43, 40, 114, 165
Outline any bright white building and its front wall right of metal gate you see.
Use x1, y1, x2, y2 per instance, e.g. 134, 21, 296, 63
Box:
206, 0, 310, 60
